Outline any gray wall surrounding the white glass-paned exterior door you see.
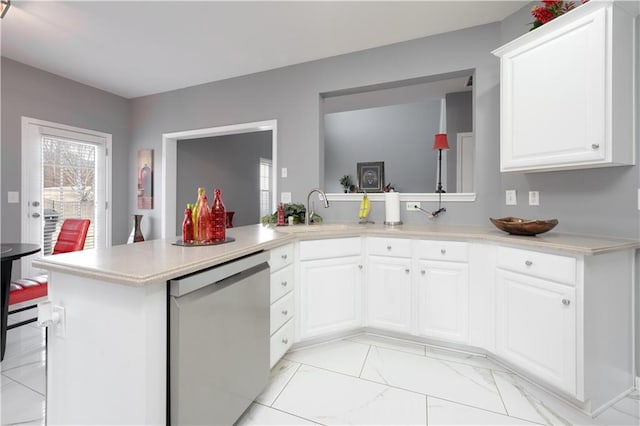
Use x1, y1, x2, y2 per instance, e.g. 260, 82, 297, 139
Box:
0, 58, 135, 274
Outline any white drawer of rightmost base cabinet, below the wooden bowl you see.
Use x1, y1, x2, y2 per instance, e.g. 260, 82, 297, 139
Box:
498, 247, 576, 285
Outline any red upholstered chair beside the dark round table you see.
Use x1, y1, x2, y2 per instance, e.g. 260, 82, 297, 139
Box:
7, 219, 91, 330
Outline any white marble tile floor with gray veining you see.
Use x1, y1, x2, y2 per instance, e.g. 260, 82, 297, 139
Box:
0, 325, 640, 426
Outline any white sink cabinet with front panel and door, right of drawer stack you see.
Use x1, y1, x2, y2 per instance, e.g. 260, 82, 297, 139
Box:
296, 238, 363, 340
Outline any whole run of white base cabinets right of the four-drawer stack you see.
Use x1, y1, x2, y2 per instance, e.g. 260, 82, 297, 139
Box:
292, 236, 635, 413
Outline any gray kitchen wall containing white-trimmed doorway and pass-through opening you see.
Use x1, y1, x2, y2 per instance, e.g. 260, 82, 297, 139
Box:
129, 24, 501, 238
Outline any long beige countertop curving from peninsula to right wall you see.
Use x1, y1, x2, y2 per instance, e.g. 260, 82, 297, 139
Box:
33, 223, 640, 287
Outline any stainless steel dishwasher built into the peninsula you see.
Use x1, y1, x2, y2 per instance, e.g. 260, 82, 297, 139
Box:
167, 248, 269, 425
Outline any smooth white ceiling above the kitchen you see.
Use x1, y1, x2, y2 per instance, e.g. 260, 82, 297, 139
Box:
2, 0, 526, 98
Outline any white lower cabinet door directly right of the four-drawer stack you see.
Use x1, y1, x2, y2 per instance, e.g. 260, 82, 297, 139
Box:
297, 256, 362, 339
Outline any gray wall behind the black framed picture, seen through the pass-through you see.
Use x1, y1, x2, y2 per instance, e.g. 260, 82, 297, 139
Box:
324, 99, 442, 192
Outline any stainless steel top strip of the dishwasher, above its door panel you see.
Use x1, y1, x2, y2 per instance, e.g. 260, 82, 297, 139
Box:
169, 251, 269, 297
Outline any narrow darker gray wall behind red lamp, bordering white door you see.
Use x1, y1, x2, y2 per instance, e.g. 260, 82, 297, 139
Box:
445, 91, 473, 192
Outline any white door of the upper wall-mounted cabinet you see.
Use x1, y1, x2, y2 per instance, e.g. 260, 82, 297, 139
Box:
500, 5, 604, 171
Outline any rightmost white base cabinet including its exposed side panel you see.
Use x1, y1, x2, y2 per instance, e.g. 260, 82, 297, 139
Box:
494, 246, 634, 412
